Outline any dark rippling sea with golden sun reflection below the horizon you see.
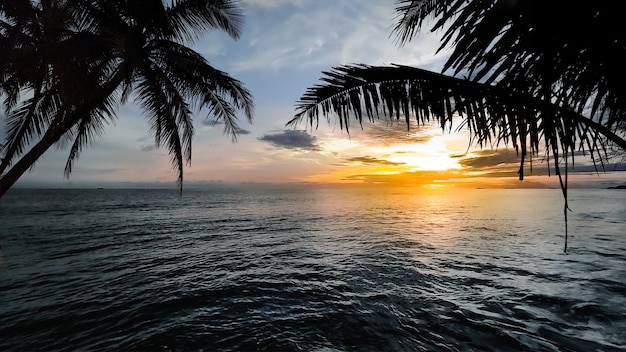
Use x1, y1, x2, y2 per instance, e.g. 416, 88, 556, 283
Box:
0, 187, 626, 351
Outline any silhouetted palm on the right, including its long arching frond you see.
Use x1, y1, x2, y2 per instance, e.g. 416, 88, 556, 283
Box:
288, 0, 626, 250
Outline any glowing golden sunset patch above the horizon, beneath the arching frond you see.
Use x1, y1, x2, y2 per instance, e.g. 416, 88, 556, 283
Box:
294, 126, 580, 189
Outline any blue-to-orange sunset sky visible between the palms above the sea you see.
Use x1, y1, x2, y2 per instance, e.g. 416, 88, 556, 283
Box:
9, 0, 625, 187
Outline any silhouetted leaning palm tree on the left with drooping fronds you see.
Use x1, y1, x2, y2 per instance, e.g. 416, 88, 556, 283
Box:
0, 0, 253, 196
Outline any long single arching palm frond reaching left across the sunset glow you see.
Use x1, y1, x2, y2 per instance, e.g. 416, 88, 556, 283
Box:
288, 65, 626, 182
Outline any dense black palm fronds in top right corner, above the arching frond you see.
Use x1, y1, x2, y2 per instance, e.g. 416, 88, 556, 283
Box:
394, 0, 626, 129
